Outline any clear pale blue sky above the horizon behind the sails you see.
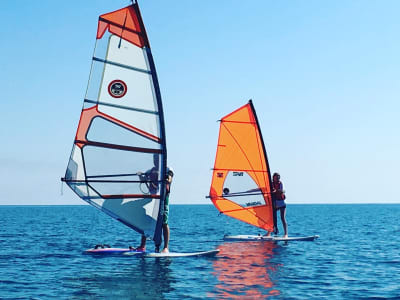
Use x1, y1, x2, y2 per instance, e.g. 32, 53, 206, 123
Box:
0, 0, 400, 204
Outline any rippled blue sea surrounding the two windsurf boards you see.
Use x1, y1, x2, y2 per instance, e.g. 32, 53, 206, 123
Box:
0, 204, 400, 299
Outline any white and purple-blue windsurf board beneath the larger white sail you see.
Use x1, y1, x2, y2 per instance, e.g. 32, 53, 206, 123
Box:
85, 248, 219, 257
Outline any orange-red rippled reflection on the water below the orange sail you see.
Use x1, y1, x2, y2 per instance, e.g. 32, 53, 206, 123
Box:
210, 242, 280, 299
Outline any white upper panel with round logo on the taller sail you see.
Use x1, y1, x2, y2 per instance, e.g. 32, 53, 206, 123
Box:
95, 35, 160, 137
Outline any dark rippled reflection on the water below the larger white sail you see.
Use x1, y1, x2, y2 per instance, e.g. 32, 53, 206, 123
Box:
64, 257, 176, 299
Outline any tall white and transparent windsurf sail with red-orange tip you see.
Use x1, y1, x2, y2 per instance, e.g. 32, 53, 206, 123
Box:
62, 2, 167, 244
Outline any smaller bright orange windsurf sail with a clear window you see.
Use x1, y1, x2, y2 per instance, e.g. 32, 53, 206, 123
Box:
209, 100, 276, 232
